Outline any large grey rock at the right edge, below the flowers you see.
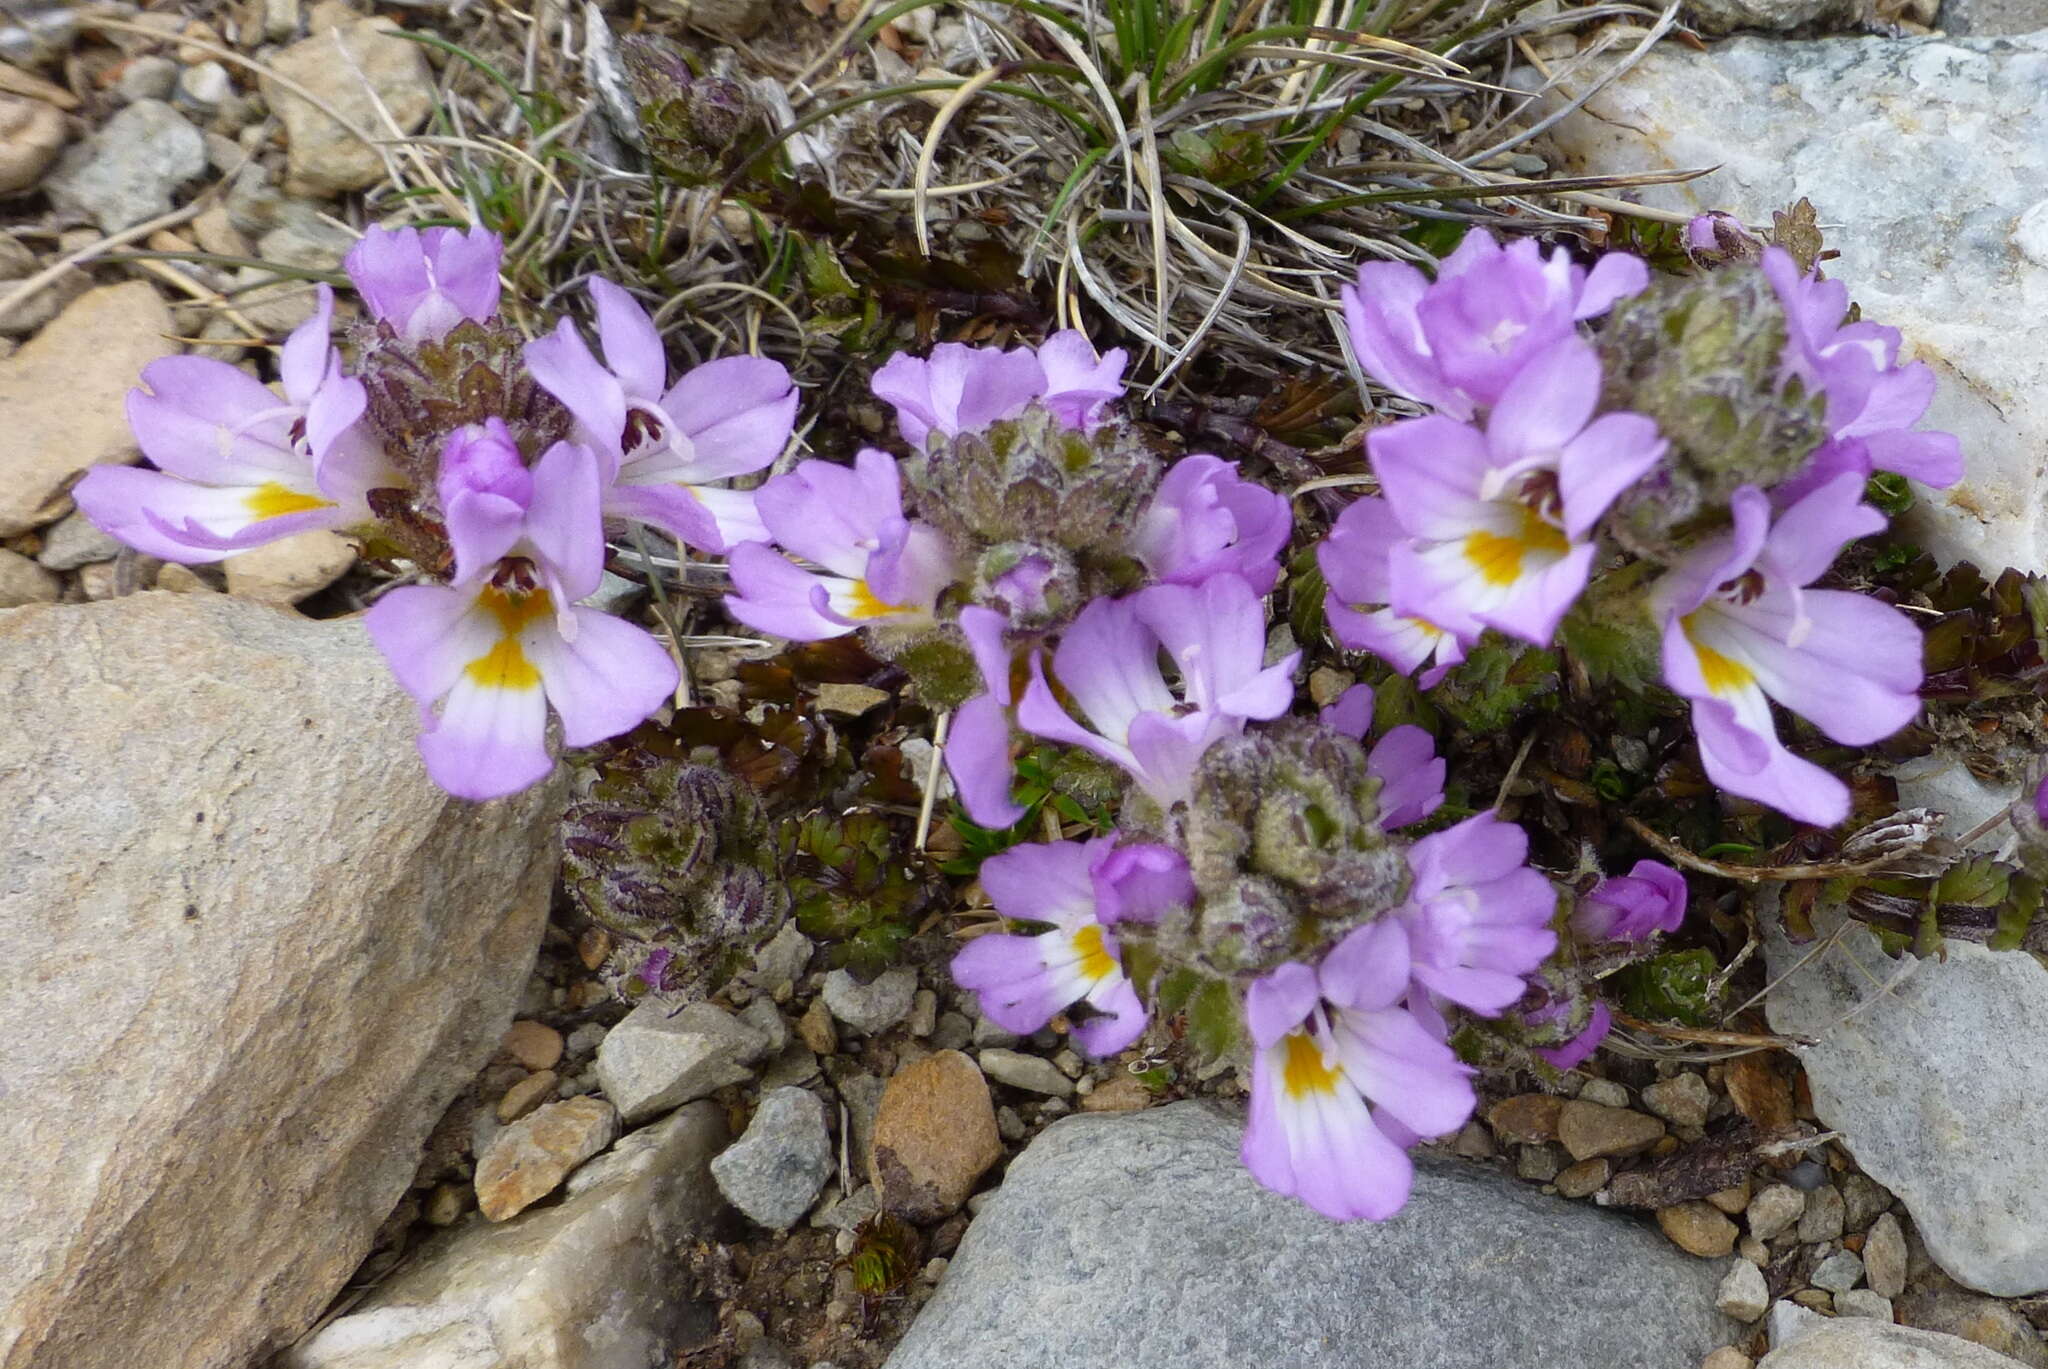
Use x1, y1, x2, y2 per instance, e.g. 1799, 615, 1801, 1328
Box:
1765, 912, 2048, 1297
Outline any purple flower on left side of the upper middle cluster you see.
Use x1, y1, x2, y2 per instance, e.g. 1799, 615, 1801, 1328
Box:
725, 447, 954, 641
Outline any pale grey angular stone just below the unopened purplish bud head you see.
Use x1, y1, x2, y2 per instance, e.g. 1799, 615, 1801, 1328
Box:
598, 1002, 768, 1125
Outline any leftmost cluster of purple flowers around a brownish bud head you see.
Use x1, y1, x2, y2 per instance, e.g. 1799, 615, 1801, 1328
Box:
76, 227, 797, 799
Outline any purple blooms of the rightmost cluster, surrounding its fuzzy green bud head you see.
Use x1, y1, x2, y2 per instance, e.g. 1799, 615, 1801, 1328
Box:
1319, 219, 1962, 826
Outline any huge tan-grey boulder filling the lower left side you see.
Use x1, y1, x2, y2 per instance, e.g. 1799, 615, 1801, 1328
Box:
0, 594, 561, 1369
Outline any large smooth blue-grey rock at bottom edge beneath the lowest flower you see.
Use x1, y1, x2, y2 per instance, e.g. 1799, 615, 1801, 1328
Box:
887, 1103, 1735, 1369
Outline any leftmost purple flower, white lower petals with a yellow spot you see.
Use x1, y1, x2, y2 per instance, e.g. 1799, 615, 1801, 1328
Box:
72, 285, 399, 562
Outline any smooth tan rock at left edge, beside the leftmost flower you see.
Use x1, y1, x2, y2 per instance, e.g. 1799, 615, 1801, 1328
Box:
0, 281, 176, 537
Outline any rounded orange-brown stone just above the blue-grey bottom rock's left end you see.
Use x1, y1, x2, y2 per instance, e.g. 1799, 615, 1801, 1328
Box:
868, 1051, 1004, 1221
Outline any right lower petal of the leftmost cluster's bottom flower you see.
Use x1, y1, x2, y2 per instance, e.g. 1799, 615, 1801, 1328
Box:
520, 607, 678, 746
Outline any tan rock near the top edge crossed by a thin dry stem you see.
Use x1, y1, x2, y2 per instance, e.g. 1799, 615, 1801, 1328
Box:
262, 6, 434, 197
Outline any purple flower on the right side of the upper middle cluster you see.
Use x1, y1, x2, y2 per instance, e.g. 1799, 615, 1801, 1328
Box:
1130, 455, 1294, 594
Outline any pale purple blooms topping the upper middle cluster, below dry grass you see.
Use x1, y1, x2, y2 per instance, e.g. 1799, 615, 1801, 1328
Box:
872, 328, 1126, 447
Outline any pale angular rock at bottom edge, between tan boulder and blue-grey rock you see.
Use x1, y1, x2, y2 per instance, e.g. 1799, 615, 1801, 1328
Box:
276, 1103, 725, 1369
